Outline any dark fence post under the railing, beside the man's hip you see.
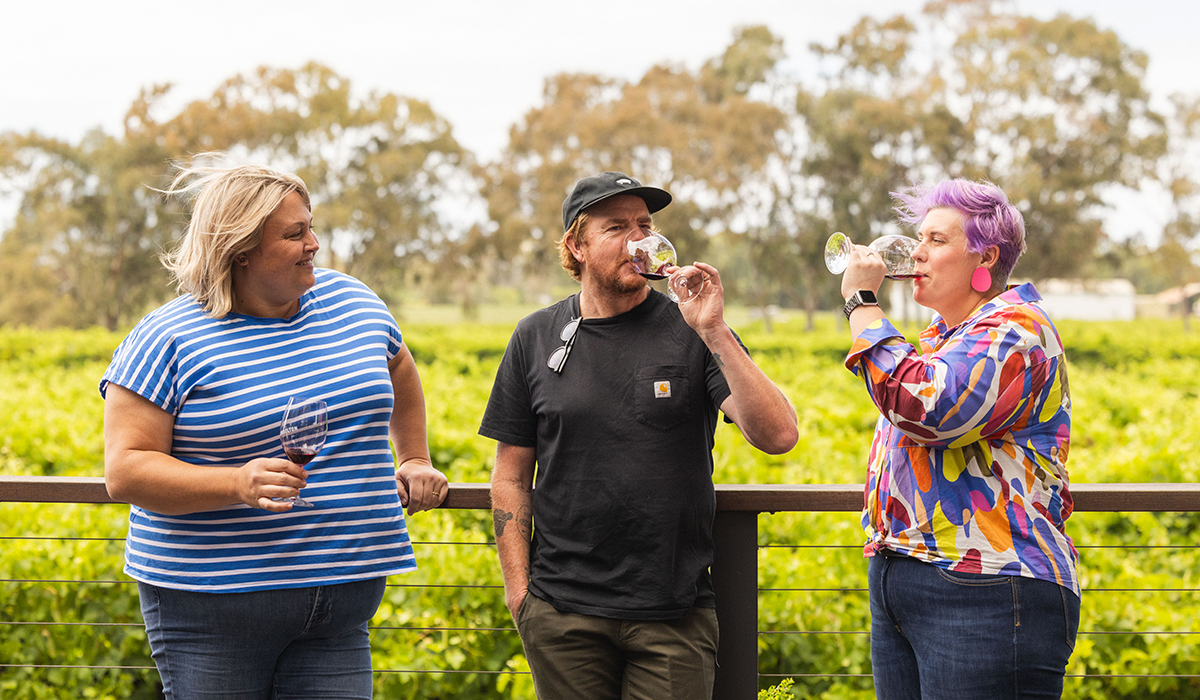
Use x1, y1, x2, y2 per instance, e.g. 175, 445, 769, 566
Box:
713, 510, 758, 700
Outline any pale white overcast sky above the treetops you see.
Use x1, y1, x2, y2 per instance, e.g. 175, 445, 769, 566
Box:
0, 0, 1200, 242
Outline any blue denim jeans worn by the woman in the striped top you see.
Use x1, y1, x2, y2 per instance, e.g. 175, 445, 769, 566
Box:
138, 578, 386, 700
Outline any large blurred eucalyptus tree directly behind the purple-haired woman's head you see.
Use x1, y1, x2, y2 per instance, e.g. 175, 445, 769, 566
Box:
798, 0, 1165, 303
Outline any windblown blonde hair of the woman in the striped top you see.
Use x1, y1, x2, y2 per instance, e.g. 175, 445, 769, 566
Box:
158, 154, 312, 318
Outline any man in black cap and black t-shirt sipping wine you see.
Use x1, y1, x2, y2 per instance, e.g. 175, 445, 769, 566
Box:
480, 173, 798, 700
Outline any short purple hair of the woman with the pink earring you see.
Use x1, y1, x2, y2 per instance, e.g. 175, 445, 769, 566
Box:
890, 179, 1025, 289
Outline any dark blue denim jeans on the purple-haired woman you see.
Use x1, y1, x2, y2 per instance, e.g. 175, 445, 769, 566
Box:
868, 554, 1079, 700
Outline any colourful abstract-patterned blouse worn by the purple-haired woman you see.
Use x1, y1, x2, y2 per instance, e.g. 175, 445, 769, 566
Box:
846, 285, 1079, 594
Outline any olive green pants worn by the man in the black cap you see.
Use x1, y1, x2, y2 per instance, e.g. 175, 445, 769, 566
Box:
517, 594, 718, 700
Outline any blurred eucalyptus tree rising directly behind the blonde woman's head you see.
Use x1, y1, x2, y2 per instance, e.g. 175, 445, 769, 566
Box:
150, 64, 476, 301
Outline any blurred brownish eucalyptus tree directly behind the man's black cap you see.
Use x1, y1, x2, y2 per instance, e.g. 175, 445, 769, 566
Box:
480, 30, 782, 301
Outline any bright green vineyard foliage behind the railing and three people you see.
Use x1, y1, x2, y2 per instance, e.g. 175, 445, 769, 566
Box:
0, 318, 1200, 699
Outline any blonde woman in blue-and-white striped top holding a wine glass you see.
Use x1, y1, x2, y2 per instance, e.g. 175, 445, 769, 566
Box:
100, 159, 446, 699
